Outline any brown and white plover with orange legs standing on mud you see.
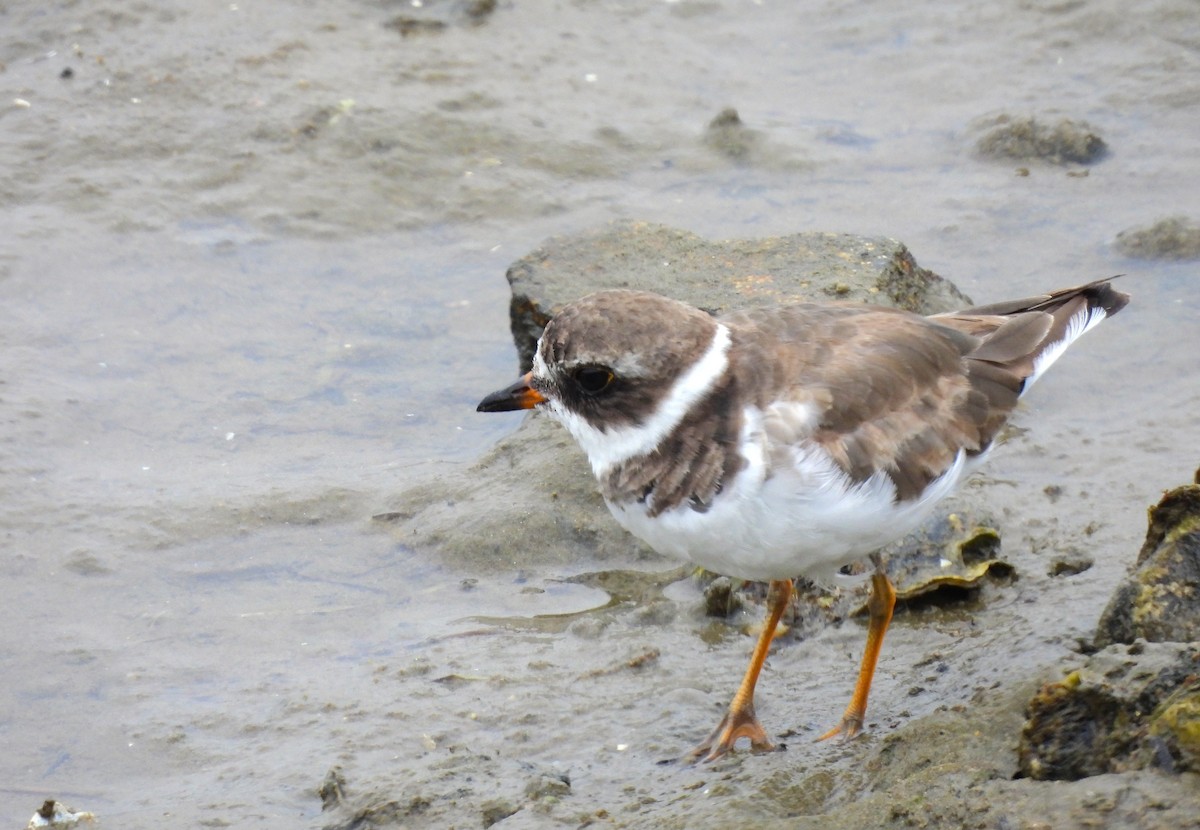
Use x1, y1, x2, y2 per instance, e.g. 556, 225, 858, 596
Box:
479, 279, 1129, 760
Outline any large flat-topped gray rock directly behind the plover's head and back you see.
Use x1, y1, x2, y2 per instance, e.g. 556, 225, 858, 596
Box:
506, 221, 971, 372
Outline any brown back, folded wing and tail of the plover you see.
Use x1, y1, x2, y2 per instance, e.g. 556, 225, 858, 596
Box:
726, 281, 1128, 500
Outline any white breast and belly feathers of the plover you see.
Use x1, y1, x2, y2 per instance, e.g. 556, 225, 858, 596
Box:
608, 408, 982, 583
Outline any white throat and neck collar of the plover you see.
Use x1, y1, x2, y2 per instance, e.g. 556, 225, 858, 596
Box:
533, 324, 730, 477
